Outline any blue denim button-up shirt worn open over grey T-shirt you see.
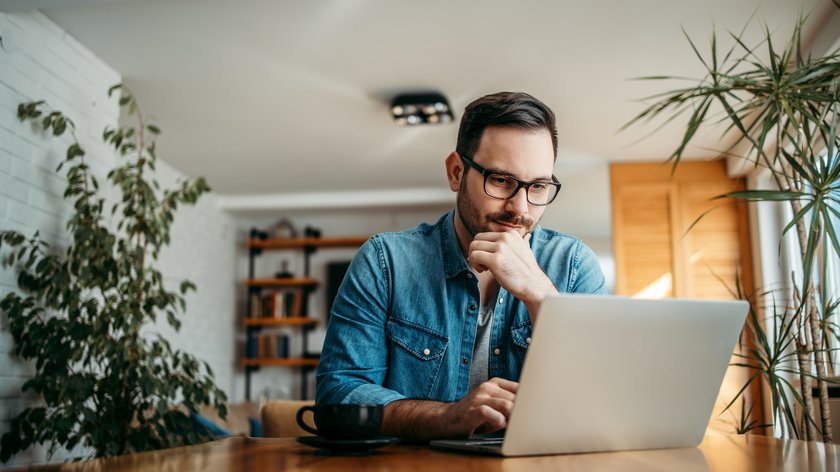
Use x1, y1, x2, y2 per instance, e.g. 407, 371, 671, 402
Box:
316, 210, 605, 405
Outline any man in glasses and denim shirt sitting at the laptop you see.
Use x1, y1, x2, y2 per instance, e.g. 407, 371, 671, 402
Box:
317, 92, 605, 441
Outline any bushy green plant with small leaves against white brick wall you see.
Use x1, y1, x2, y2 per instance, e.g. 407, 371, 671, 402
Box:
0, 85, 226, 462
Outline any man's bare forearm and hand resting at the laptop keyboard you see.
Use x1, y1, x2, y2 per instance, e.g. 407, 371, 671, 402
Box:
382, 377, 519, 442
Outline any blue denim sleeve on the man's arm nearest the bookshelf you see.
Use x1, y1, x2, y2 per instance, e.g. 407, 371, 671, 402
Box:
316, 236, 405, 405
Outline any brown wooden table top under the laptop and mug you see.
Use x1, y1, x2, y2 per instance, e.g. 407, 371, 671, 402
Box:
18, 435, 840, 472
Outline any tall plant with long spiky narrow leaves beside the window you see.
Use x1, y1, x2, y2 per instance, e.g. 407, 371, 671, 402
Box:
625, 7, 840, 442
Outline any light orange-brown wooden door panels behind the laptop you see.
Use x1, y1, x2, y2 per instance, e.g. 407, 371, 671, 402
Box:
610, 160, 762, 433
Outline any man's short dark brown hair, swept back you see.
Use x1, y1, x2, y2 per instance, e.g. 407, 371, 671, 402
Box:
455, 92, 557, 159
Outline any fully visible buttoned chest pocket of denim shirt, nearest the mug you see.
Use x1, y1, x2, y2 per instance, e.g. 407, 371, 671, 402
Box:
385, 318, 448, 399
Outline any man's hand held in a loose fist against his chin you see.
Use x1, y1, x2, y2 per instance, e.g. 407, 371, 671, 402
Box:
467, 231, 557, 322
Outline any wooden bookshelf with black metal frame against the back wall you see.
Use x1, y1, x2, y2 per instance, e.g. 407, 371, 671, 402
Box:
246, 236, 368, 400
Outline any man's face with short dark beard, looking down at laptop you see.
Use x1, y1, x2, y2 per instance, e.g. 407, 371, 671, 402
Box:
456, 127, 554, 237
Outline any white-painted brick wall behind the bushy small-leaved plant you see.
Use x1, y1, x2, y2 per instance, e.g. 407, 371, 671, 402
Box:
0, 12, 235, 465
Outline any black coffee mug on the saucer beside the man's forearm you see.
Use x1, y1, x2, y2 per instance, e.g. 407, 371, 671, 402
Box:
297, 403, 385, 439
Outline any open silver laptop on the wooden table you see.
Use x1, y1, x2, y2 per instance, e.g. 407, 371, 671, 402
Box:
431, 294, 748, 456
